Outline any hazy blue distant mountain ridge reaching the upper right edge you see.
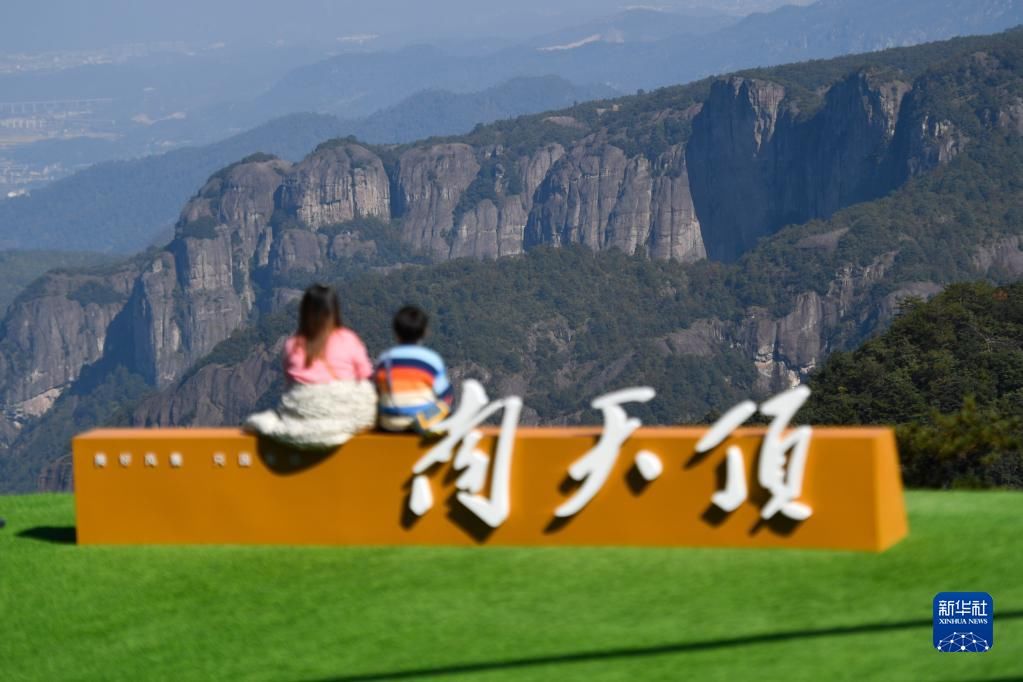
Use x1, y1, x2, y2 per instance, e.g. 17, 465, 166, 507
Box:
259, 0, 1023, 115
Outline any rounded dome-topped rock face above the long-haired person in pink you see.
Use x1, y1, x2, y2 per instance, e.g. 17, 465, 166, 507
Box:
278, 143, 391, 229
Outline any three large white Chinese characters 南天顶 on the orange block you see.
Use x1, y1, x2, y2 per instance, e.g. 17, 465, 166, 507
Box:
408, 379, 812, 528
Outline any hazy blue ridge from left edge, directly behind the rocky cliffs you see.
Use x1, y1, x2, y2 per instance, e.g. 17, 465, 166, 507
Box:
0, 77, 613, 253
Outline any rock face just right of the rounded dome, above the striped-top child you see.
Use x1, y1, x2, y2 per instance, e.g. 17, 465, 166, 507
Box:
398, 143, 480, 260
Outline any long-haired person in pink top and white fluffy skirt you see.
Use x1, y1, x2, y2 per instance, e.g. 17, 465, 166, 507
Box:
246, 284, 376, 448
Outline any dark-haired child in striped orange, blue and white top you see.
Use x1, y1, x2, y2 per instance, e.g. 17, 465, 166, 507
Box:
373, 306, 453, 435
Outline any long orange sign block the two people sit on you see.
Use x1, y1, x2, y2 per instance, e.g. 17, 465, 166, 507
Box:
74, 427, 907, 551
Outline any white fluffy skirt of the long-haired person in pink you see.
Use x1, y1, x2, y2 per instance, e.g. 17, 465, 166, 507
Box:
244, 381, 376, 449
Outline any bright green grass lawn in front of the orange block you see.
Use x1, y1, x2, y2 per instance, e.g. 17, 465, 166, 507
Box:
0, 492, 1023, 682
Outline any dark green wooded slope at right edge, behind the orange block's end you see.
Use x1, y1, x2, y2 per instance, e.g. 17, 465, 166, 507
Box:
800, 282, 1023, 488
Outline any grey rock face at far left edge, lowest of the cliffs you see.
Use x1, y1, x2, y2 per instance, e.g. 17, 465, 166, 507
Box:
0, 262, 138, 423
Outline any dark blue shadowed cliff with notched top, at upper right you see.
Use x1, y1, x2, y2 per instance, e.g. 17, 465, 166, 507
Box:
686, 73, 909, 260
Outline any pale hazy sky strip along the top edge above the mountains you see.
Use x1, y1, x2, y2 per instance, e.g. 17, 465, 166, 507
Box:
0, 0, 812, 53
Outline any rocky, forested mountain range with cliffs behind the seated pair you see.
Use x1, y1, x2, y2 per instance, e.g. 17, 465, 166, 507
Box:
0, 30, 1023, 490
